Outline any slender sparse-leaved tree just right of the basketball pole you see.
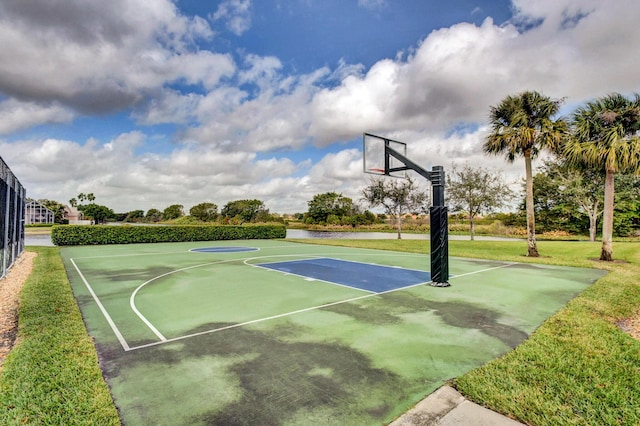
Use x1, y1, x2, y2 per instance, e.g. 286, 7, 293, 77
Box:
447, 163, 513, 240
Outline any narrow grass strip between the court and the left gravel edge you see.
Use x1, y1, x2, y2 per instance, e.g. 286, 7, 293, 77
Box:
0, 247, 120, 425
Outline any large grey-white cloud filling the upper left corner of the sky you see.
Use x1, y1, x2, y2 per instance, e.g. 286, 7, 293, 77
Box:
0, 0, 221, 113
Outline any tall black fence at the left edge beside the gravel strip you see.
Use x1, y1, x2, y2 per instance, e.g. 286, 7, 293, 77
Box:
0, 157, 27, 278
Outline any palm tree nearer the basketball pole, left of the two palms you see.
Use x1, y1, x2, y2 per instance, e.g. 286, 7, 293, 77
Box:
483, 91, 567, 257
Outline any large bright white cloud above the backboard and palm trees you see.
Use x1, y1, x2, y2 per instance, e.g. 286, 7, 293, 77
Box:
310, 0, 640, 145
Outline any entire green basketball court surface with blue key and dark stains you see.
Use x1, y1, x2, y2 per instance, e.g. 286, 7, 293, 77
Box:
61, 240, 603, 425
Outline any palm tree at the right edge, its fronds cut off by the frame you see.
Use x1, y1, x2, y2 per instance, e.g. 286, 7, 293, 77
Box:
565, 93, 640, 261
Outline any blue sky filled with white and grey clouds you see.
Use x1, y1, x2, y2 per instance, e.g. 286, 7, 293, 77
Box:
0, 0, 640, 214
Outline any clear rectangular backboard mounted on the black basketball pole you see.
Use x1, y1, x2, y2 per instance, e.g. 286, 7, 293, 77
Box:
362, 133, 407, 178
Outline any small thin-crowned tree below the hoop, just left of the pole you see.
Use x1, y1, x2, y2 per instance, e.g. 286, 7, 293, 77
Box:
361, 178, 429, 239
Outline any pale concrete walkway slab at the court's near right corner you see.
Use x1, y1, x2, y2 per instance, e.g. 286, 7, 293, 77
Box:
390, 386, 523, 426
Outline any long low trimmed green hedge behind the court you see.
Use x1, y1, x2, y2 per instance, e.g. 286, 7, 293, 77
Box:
51, 224, 287, 246
